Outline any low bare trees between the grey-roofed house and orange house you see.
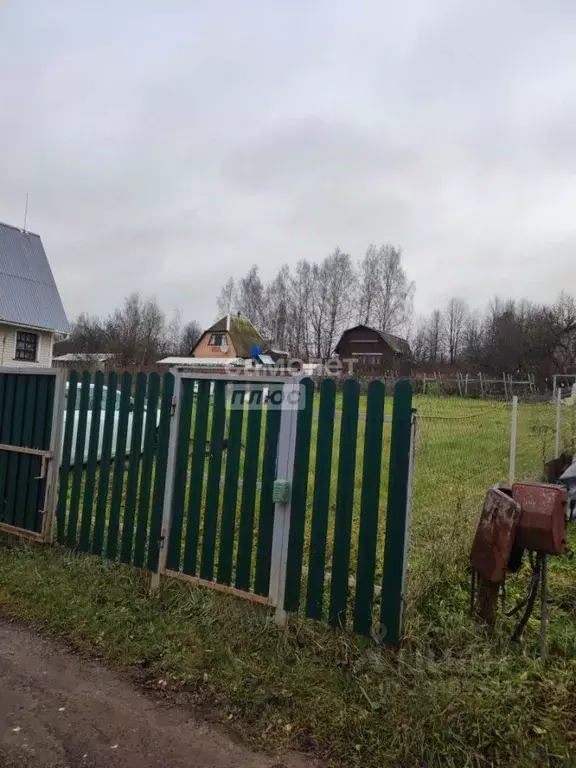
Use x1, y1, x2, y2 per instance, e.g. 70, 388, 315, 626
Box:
57, 293, 202, 365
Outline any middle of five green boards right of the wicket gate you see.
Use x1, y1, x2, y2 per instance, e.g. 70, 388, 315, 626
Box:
329, 379, 360, 627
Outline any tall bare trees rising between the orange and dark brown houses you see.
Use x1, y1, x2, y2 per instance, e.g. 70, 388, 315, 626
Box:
217, 245, 414, 358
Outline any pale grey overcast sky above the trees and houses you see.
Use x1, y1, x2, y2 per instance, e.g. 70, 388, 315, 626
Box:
0, 0, 576, 324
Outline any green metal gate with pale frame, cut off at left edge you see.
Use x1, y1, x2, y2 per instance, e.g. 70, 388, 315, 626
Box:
0, 368, 64, 540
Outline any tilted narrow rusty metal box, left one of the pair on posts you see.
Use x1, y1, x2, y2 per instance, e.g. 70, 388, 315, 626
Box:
470, 487, 521, 594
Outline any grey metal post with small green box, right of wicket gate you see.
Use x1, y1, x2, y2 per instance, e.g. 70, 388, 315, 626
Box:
268, 376, 305, 626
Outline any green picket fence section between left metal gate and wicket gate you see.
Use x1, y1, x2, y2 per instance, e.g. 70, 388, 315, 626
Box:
56, 371, 174, 570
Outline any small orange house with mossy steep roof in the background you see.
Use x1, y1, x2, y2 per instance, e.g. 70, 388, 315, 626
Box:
158, 315, 283, 368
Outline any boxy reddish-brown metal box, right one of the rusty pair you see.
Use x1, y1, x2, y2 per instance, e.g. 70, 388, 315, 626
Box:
512, 483, 568, 555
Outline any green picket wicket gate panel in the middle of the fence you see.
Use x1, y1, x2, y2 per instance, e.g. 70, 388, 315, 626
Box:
166, 378, 281, 596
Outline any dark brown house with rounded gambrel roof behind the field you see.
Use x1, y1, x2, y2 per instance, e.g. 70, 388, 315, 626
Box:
334, 325, 412, 375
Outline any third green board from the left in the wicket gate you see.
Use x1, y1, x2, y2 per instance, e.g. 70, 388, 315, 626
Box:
200, 381, 226, 581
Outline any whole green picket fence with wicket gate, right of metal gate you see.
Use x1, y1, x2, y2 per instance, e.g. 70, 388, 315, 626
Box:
56, 372, 412, 642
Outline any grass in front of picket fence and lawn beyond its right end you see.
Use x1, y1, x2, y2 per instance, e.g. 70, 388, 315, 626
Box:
6, 397, 576, 768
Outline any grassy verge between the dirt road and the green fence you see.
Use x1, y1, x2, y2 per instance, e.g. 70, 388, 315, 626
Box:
0, 546, 576, 768
